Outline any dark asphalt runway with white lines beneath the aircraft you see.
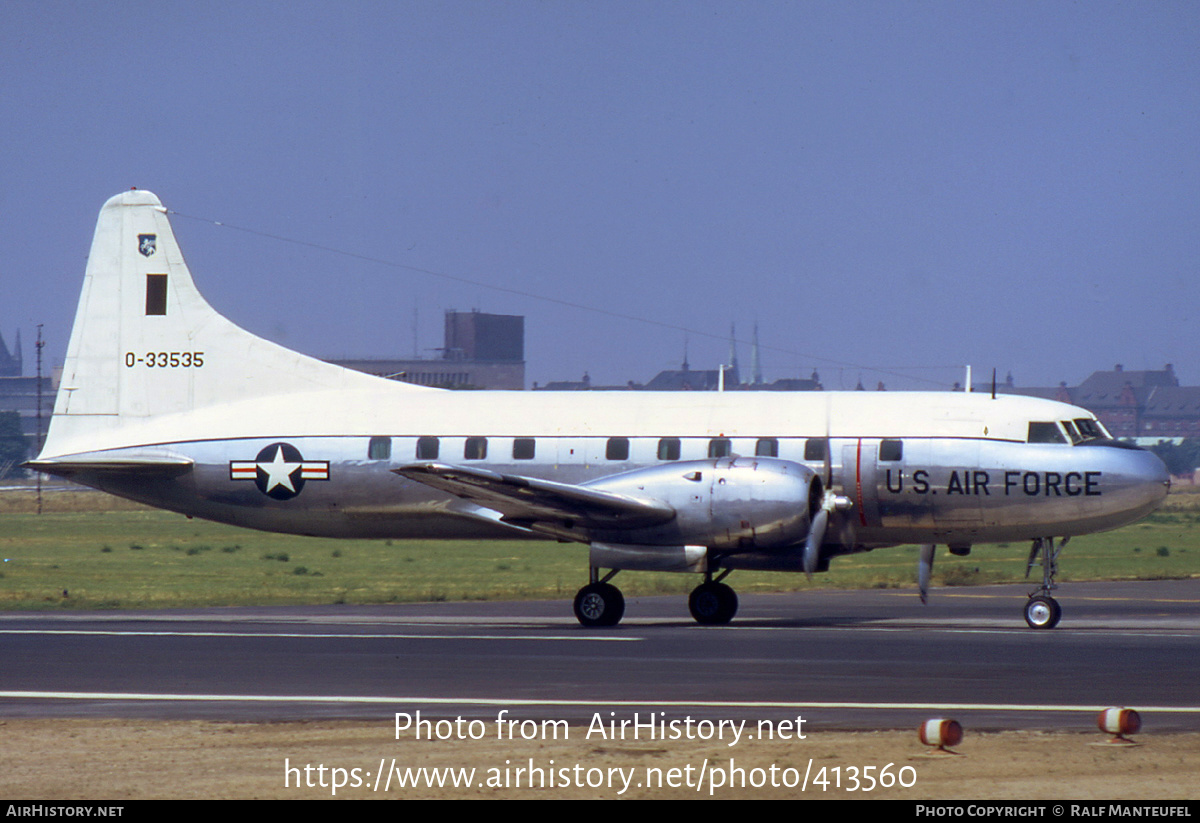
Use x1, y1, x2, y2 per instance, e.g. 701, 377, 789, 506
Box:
0, 581, 1200, 731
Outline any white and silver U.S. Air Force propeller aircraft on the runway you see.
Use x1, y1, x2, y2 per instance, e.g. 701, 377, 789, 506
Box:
28, 191, 1169, 629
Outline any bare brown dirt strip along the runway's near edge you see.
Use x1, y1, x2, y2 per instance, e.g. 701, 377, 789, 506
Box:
0, 720, 1200, 800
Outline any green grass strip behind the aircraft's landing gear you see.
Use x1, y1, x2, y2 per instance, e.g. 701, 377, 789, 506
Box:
0, 495, 1200, 609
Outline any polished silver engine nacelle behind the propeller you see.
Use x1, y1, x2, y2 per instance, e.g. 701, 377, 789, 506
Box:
587, 457, 824, 551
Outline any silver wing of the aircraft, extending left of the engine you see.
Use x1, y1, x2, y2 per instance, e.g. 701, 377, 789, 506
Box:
392, 463, 676, 529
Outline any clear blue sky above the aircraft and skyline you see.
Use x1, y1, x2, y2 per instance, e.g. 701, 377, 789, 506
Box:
0, 0, 1200, 389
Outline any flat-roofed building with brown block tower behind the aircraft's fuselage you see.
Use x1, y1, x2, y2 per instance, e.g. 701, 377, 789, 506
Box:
329, 311, 524, 390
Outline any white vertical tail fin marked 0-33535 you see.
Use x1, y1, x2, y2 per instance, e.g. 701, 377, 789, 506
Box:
43, 191, 420, 456
